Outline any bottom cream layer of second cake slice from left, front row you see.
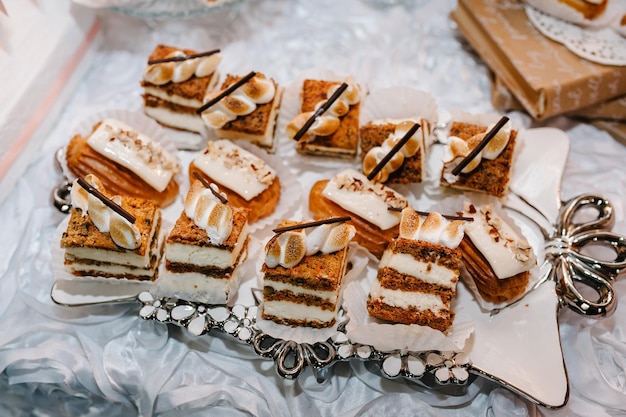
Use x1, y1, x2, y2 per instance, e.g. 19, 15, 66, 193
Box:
156, 268, 239, 304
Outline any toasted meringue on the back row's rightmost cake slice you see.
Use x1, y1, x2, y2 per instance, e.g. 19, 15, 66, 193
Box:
444, 121, 511, 174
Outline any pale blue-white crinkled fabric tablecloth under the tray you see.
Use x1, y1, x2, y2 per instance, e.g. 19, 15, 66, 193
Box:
0, 0, 626, 417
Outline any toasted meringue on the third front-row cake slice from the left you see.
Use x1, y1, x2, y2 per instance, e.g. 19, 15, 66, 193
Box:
265, 223, 356, 268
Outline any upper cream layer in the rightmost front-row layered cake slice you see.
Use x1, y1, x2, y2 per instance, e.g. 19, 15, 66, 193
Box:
379, 251, 458, 289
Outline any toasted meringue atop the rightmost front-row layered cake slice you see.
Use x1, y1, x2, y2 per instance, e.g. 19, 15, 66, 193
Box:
400, 207, 465, 249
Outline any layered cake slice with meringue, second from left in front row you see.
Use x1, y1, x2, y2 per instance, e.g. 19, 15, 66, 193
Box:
157, 180, 248, 304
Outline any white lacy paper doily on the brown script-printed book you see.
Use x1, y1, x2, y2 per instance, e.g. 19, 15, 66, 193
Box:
526, 5, 626, 66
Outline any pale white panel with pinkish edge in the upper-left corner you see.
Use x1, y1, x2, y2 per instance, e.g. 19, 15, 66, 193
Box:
0, 0, 101, 203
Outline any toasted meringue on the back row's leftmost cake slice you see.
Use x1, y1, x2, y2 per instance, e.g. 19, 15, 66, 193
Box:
143, 51, 222, 85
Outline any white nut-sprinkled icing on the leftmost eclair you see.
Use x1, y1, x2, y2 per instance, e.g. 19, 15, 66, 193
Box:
87, 119, 179, 192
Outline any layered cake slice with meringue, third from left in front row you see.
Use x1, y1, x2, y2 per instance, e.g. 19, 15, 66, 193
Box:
262, 219, 355, 328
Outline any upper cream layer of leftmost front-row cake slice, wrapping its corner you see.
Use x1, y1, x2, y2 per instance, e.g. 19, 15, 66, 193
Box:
65, 212, 162, 270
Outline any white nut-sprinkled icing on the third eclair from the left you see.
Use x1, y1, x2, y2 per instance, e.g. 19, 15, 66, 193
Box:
322, 169, 408, 230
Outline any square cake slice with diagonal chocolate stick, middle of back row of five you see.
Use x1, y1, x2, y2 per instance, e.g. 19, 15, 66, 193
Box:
286, 77, 361, 158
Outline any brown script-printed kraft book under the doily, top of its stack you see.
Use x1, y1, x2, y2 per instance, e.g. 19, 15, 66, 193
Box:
451, 0, 626, 120
